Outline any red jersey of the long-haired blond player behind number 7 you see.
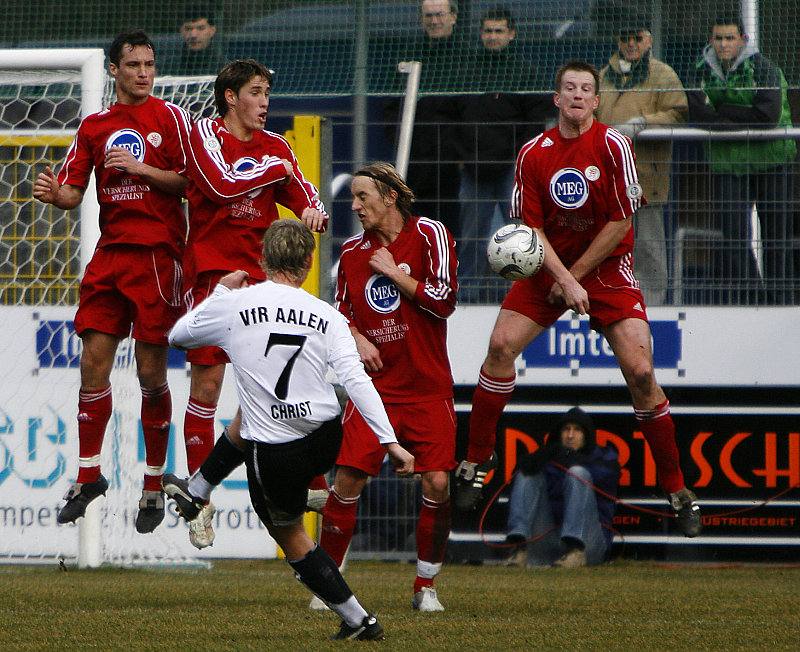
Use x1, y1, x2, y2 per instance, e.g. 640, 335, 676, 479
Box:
336, 217, 458, 403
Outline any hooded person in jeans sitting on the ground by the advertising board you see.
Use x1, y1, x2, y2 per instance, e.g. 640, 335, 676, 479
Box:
506, 407, 619, 568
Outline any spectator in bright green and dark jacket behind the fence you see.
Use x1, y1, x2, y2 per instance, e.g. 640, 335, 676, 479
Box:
688, 14, 796, 305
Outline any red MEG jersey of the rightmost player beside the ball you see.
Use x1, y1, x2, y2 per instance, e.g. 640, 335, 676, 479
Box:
511, 120, 646, 268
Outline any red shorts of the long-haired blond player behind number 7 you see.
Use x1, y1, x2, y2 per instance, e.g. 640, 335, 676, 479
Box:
336, 398, 456, 476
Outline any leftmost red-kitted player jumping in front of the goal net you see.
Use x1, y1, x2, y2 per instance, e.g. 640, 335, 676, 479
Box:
33, 30, 191, 534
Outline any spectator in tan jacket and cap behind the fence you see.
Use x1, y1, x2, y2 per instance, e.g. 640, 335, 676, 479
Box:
597, 20, 688, 305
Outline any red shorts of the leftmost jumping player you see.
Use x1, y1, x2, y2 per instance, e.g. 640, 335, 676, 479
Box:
75, 245, 184, 346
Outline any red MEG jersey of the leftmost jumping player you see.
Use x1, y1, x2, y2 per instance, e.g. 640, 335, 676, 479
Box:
58, 97, 192, 259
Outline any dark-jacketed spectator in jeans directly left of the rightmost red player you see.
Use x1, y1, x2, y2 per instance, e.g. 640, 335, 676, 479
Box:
456, 7, 556, 301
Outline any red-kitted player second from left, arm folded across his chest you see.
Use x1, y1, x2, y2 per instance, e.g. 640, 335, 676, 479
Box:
173, 59, 328, 548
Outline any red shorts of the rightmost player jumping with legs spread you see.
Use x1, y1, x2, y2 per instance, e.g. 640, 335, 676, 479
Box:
502, 254, 647, 331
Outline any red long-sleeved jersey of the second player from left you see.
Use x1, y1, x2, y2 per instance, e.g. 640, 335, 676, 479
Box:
186, 118, 325, 283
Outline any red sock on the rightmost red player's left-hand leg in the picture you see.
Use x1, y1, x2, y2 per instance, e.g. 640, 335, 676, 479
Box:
467, 369, 517, 462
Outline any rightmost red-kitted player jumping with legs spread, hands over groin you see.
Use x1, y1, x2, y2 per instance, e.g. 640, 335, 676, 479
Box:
455, 61, 702, 537
